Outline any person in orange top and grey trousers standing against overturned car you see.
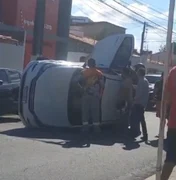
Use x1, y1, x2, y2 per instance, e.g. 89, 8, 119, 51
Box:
81, 59, 104, 132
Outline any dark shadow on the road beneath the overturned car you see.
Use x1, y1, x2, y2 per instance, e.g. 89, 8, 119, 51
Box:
0, 128, 153, 151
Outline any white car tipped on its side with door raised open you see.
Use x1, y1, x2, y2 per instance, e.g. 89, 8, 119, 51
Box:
19, 35, 134, 127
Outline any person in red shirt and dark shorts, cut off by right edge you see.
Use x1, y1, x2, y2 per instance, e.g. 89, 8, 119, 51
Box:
161, 67, 176, 180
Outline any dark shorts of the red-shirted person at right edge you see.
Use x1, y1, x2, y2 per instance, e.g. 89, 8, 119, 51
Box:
166, 129, 176, 165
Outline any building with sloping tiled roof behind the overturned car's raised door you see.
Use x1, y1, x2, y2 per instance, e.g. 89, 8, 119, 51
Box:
67, 21, 126, 61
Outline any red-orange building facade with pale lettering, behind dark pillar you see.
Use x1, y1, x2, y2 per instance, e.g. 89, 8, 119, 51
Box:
0, 0, 72, 66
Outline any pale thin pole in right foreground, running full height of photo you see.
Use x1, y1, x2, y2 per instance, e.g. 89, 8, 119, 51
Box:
156, 0, 175, 180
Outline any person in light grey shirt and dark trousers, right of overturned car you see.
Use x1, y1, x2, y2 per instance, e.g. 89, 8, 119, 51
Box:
130, 68, 149, 142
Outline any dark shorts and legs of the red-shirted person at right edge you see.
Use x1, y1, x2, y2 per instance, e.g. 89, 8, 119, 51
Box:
161, 130, 176, 180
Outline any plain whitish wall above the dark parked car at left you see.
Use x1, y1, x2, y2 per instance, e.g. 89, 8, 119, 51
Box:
0, 43, 24, 71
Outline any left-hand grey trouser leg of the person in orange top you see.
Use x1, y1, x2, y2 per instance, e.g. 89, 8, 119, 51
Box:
82, 95, 91, 132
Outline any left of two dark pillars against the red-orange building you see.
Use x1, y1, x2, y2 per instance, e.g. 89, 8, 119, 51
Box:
31, 0, 46, 60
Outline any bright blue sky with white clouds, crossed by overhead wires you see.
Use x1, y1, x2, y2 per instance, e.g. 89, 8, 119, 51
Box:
72, 0, 176, 52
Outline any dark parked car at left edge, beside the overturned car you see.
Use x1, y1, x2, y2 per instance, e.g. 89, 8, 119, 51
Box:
0, 68, 21, 116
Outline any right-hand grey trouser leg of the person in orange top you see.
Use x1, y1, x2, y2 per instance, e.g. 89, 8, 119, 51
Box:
90, 96, 100, 132
